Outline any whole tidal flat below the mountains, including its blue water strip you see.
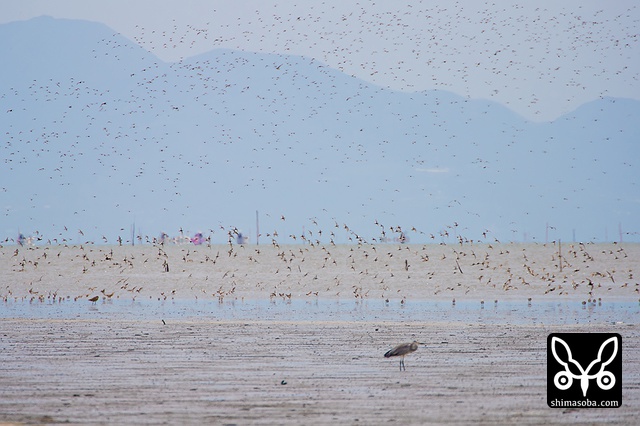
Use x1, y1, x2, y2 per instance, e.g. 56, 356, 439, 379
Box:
0, 244, 640, 424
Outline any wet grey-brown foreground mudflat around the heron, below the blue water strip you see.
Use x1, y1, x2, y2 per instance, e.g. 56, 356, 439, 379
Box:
0, 318, 640, 424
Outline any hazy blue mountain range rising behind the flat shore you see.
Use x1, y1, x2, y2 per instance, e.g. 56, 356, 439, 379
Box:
0, 17, 640, 242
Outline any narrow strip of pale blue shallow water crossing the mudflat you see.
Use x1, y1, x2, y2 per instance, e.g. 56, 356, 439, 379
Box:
0, 299, 640, 325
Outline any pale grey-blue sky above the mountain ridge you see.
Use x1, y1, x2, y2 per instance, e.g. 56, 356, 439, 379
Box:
0, 0, 640, 121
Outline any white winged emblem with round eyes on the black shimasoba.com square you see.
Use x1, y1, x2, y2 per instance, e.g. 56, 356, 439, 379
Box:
551, 336, 618, 398
